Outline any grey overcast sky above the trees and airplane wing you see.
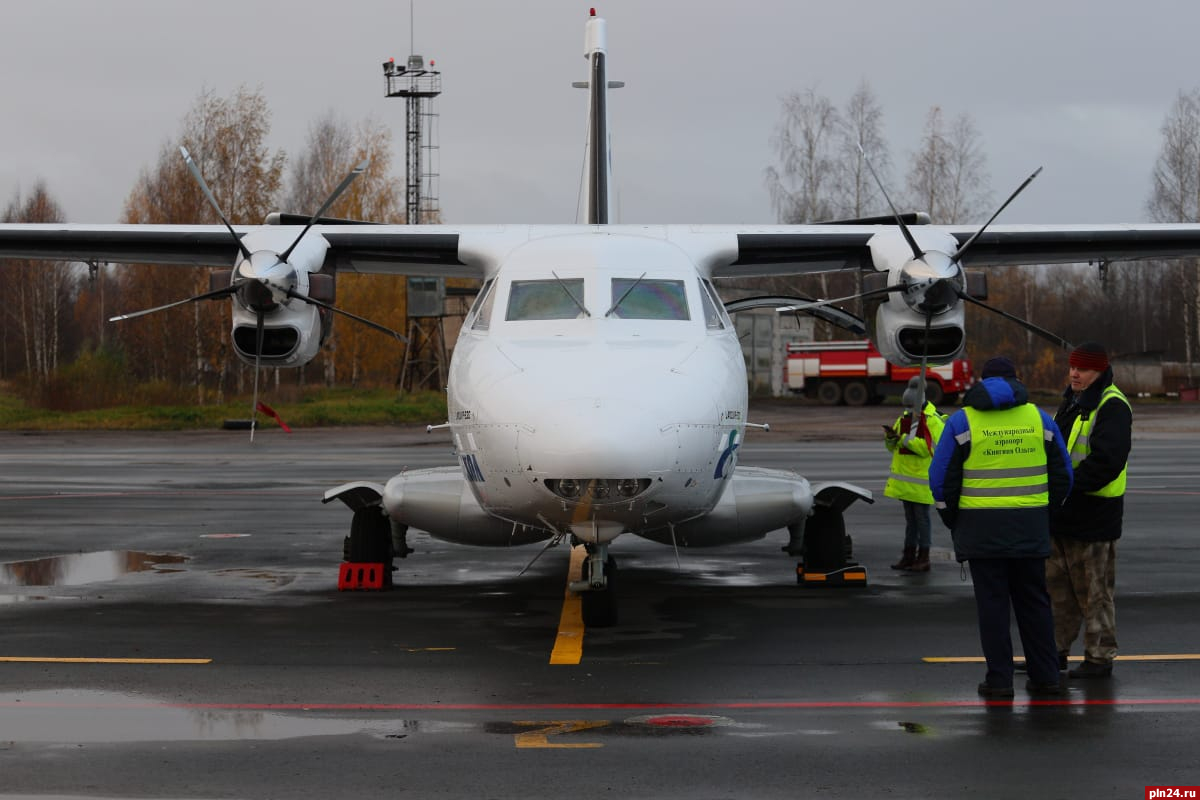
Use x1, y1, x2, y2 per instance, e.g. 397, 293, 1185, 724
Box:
0, 0, 1200, 223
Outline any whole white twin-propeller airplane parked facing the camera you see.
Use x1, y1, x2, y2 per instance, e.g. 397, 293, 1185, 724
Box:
0, 13, 1200, 626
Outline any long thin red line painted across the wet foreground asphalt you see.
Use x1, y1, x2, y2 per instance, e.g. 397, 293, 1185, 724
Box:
0, 697, 1200, 711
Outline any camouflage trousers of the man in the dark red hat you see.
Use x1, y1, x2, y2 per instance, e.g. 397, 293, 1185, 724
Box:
1046, 536, 1117, 663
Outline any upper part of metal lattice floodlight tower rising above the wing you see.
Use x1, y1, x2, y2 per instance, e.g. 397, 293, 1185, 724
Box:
383, 55, 442, 225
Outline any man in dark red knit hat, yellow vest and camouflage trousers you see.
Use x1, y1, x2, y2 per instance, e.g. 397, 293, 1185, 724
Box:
1046, 342, 1133, 678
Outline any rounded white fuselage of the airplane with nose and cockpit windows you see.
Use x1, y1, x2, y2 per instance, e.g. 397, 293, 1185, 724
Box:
448, 230, 746, 542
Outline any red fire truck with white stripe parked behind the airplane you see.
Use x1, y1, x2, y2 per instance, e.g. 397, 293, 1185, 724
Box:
784, 339, 973, 405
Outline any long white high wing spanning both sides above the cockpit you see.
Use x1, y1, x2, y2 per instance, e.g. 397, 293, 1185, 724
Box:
9, 224, 1200, 278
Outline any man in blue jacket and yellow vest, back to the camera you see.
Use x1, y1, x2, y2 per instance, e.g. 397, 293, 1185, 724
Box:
929, 357, 1072, 699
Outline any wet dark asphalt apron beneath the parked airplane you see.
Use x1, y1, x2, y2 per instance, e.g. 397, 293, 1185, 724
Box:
0, 408, 1200, 798
